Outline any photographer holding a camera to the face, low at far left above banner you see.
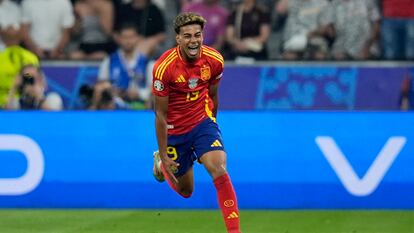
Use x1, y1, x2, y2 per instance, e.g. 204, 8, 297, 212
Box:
8, 65, 63, 110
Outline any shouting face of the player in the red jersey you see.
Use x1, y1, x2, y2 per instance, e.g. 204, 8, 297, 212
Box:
176, 24, 203, 61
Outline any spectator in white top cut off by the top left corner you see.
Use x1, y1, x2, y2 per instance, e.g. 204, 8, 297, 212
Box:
0, 0, 21, 51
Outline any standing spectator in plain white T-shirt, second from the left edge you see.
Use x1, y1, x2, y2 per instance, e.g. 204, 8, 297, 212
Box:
22, 0, 74, 59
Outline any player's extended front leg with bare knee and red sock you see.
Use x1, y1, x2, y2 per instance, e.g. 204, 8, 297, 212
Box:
200, 150, 240, 233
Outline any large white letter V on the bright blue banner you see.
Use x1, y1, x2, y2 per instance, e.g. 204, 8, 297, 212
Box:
315, 136, 407, 196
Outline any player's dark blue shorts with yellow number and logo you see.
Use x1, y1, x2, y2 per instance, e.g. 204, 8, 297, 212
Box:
167, 118, 224, 177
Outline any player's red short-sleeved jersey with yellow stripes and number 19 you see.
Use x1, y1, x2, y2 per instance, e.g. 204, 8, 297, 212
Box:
152, 45, 224, 135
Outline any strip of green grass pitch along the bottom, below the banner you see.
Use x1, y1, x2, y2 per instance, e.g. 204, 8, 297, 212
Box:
0, 209, 414, 233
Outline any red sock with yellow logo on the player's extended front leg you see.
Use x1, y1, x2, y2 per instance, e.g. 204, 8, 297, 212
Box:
214, 173, 240, 233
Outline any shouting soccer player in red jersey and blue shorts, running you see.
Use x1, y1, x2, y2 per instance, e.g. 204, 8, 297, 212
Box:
152, 12, 240, 233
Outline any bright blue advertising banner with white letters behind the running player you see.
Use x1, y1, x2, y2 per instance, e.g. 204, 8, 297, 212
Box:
0, 111, 414, 209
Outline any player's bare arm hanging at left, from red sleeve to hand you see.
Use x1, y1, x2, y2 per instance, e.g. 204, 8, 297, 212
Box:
155, 91, 179, 183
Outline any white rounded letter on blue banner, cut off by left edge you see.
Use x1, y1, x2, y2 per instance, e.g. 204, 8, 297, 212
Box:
0, 134, 44, 195
